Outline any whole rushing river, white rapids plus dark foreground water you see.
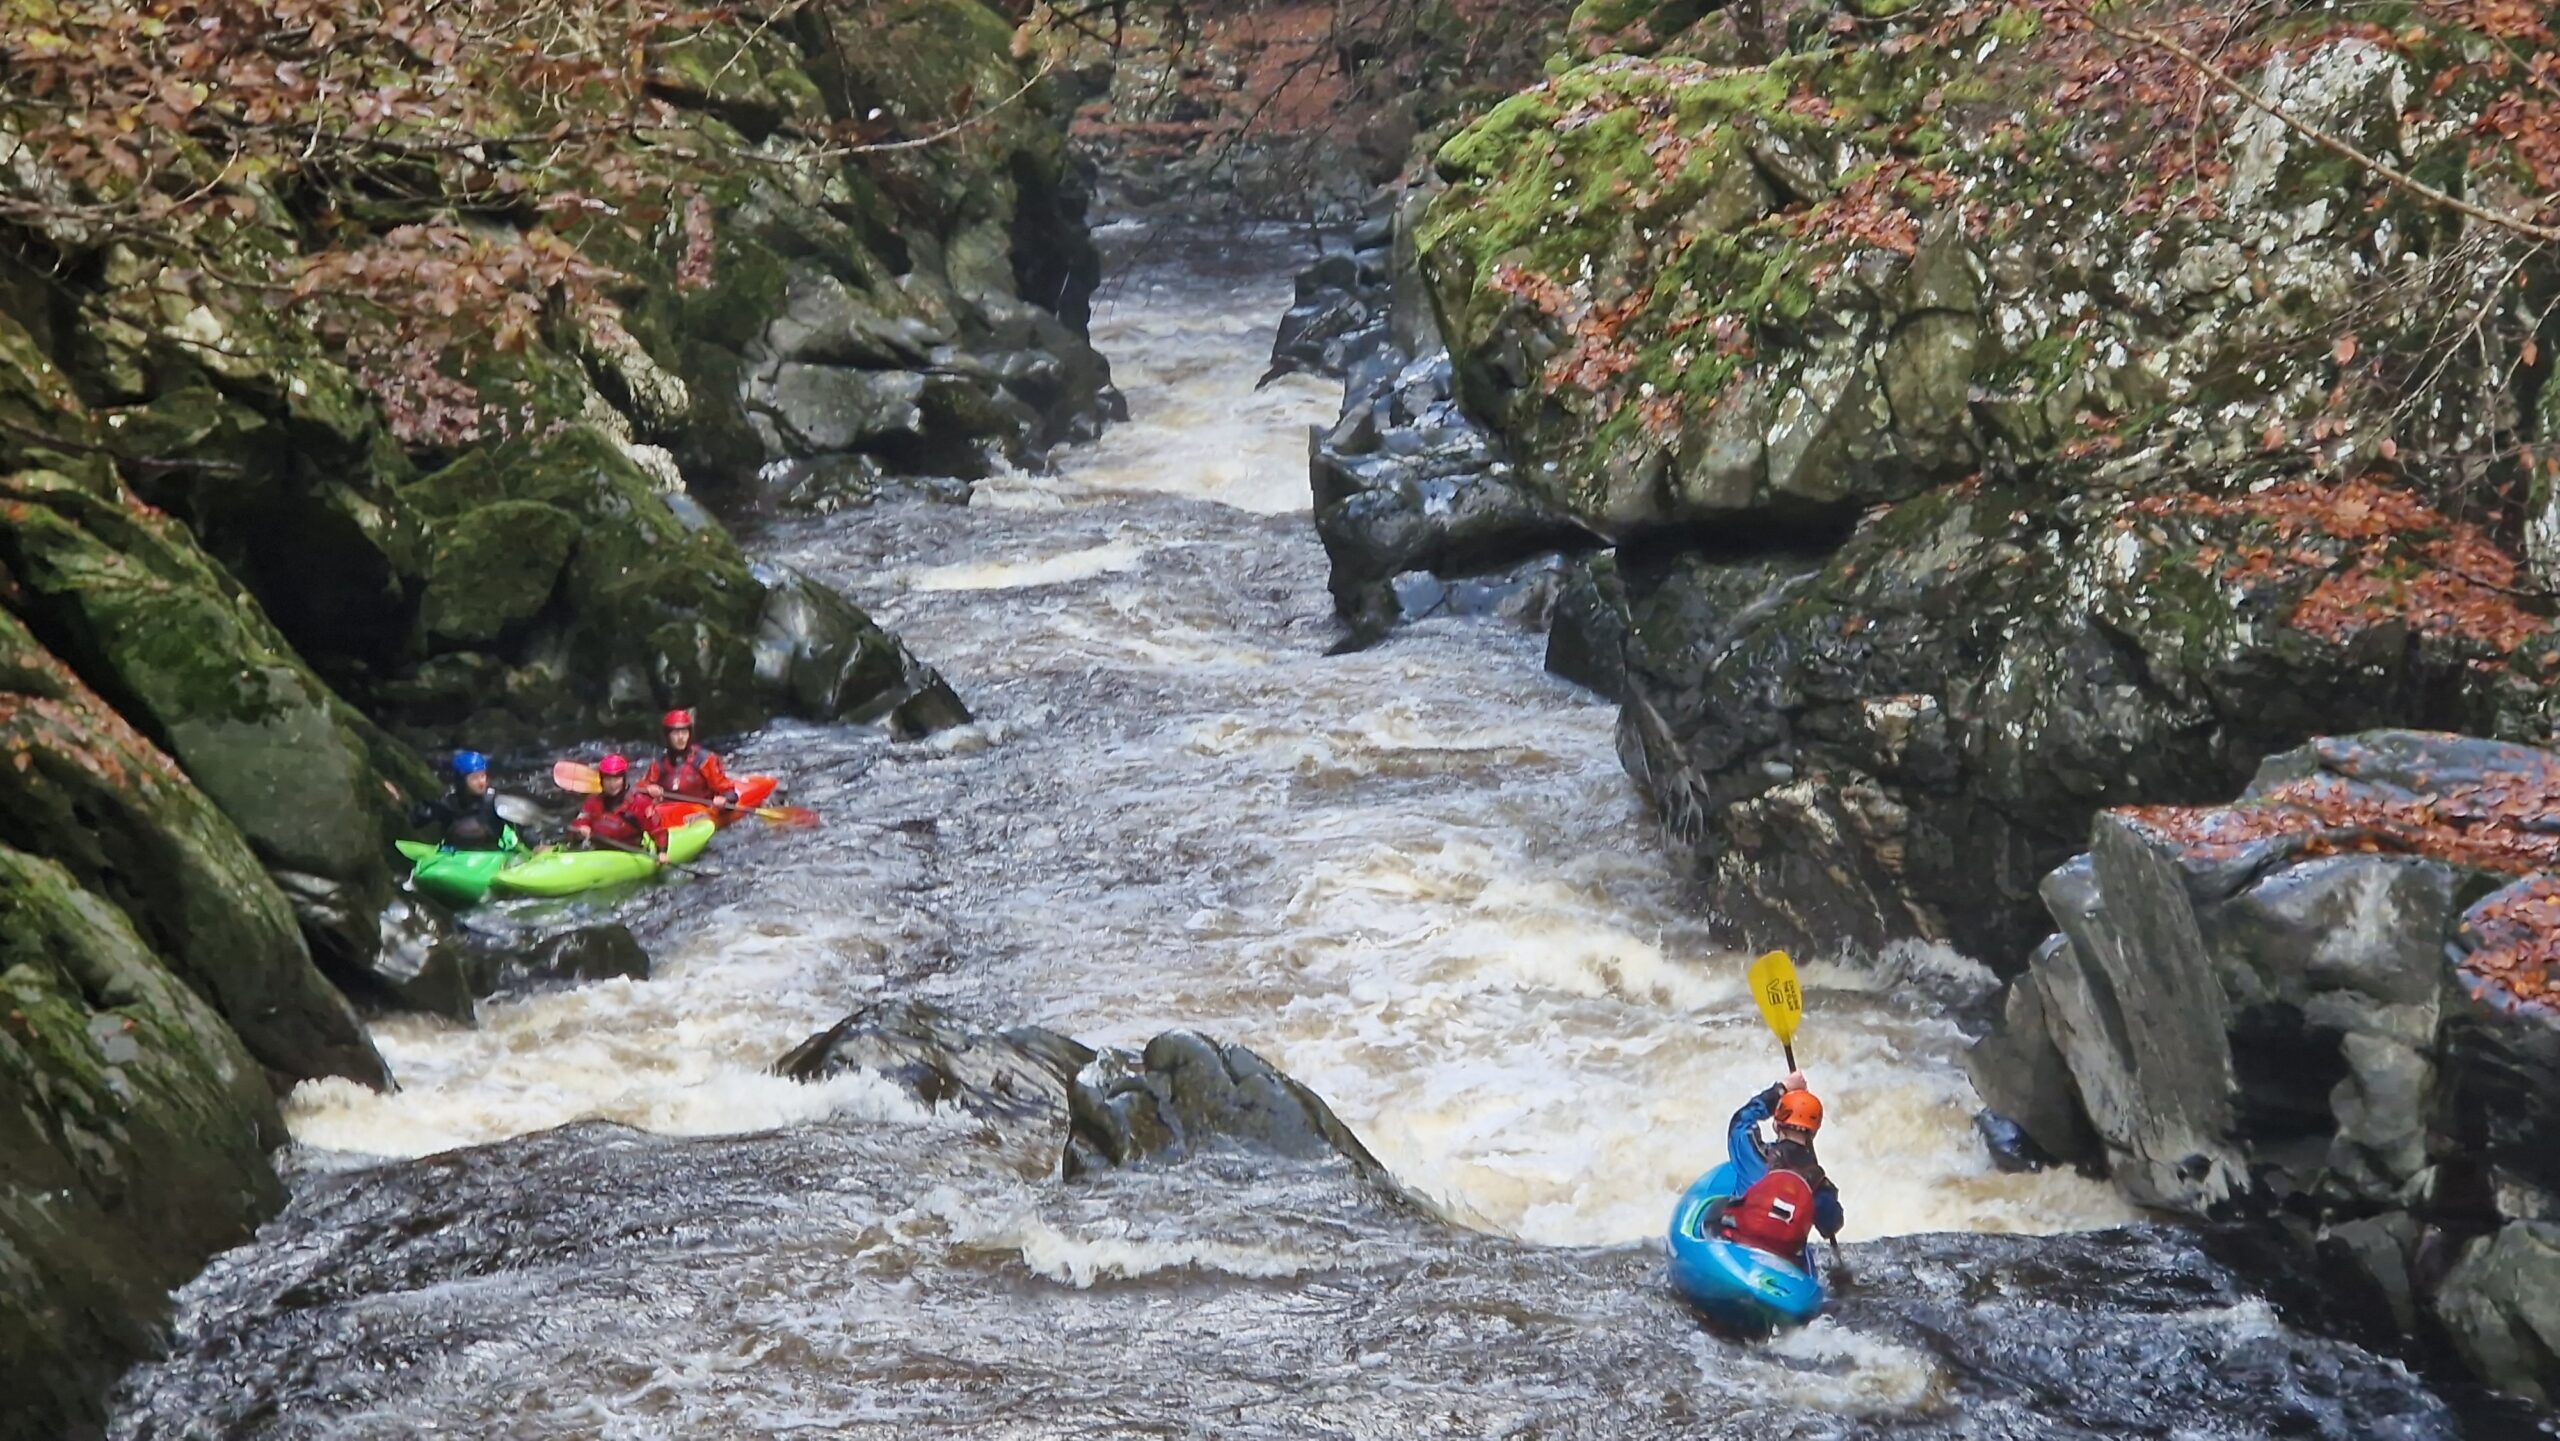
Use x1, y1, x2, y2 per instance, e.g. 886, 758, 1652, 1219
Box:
120, 231, 2478, 1438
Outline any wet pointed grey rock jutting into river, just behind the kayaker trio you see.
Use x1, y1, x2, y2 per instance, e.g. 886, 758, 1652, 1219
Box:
755, 566, 970, 737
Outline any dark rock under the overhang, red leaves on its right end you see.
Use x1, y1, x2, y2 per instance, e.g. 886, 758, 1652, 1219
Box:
1620, 484, 2552, 970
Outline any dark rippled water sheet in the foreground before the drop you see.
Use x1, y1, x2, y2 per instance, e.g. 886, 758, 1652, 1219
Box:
113, 1054, 2460, 1441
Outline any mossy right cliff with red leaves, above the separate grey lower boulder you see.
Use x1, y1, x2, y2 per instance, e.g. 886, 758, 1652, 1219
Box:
1408, 5, 2560, 970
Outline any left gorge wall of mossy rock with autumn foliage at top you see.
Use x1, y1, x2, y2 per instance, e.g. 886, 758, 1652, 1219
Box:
0, 0, 1116, 1436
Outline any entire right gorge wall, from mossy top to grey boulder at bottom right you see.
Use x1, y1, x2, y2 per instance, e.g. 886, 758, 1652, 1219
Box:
1283, 3, 2560, 1392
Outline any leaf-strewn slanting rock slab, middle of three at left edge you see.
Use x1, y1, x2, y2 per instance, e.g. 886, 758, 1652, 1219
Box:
0, 612, 389, 1085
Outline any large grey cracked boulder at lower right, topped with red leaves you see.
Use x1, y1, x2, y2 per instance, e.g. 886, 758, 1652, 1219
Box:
1974, 732, 2560, 1395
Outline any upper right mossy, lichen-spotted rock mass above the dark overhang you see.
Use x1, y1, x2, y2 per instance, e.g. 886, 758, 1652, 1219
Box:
1418, 35, 2560, 547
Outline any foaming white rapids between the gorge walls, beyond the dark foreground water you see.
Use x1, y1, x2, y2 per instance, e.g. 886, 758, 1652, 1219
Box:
292, 231, 2127, 1243
